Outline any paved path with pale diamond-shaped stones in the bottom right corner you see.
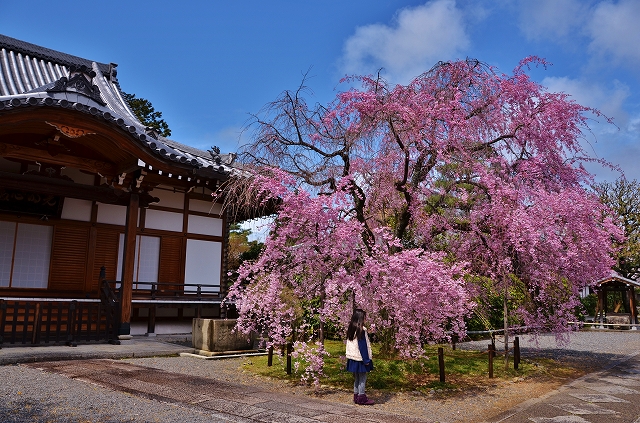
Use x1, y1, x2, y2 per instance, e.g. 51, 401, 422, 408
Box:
491, 353, 640, 423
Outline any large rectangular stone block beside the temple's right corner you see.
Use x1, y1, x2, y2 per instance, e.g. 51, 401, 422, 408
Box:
191, 318, 255, 352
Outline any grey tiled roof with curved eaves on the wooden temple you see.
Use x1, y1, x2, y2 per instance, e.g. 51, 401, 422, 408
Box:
0, 35, 233, 179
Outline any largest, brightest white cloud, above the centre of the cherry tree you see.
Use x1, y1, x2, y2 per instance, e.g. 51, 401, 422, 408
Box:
342, 0, 469, 83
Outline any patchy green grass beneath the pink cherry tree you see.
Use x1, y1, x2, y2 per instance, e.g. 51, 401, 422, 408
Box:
240, 341, 576, 393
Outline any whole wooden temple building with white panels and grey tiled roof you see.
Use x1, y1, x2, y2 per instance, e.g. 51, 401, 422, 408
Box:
0, 35, 238, 347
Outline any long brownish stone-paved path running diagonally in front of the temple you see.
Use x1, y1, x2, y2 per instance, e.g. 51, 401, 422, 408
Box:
24, 359, 428, 423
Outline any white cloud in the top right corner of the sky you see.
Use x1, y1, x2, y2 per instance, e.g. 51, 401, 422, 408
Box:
588, 0, 640, 64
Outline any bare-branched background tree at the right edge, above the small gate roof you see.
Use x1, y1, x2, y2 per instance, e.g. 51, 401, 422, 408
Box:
595, 178, 640, 280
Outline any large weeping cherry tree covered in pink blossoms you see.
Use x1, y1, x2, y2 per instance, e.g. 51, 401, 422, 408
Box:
225, 58, 619, 380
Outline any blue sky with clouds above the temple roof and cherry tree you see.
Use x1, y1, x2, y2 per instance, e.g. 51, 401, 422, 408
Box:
0, 0, 640, 180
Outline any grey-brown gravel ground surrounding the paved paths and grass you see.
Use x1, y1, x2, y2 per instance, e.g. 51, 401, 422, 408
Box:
0, 331, 640, 423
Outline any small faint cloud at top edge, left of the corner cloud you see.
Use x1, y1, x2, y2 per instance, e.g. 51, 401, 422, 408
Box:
519, 0, 589, 41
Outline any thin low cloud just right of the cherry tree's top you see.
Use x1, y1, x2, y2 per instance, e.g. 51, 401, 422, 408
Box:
542, 77, 630, 126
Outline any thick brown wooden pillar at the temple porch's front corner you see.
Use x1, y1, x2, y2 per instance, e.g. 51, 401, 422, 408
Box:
118, 192, 140, 339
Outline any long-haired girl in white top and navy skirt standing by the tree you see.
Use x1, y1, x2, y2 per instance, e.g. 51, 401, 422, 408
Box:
346, 309, 374, 405
